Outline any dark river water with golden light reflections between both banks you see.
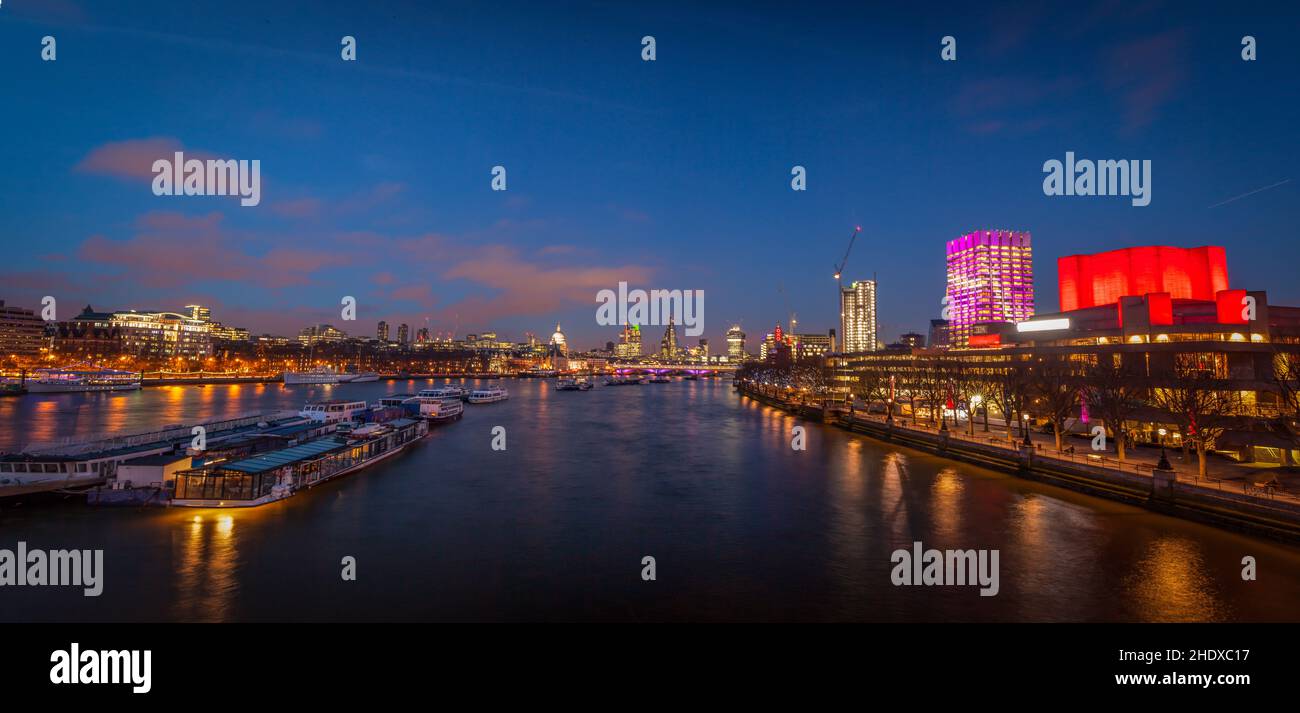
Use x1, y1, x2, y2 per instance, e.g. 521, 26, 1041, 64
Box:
0, 380, 1300, 622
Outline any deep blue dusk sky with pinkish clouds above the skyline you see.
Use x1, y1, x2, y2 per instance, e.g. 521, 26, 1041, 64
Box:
0, 0, 1300, 347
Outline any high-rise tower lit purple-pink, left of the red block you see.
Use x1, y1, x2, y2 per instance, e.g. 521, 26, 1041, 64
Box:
946, 230, 1034, 349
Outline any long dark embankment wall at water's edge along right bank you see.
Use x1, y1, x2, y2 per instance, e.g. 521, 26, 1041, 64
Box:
737, 384, 1300, 543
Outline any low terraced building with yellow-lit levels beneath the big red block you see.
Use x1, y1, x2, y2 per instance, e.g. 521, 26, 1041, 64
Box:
828, 284, 1300, 484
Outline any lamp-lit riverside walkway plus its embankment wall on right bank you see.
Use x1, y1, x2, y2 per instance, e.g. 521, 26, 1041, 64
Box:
737, 384, 1300, 543
